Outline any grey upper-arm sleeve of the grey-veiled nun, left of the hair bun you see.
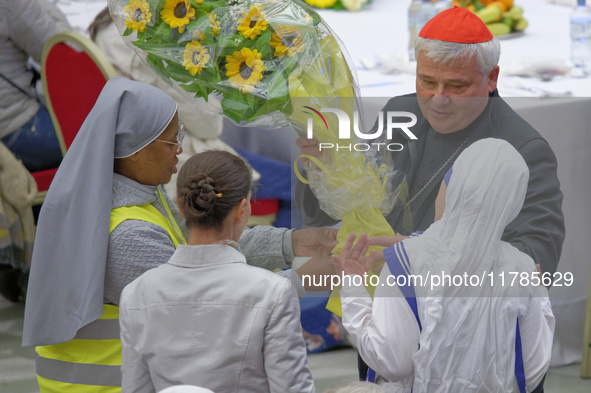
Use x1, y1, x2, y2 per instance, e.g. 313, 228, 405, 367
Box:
104, 220, 175, 305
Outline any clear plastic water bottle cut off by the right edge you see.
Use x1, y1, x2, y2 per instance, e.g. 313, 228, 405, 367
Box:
570, 0, 591, 77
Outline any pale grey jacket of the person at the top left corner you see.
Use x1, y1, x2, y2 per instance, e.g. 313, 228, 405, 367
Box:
0, 0, 69, 138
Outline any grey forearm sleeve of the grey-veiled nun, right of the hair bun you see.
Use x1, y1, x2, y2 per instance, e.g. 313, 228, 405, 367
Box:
238, 225, 294, 270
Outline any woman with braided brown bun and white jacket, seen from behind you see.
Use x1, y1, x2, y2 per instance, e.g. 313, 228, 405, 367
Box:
119, 151, 314, 393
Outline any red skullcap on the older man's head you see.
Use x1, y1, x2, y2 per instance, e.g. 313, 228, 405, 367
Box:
419, 6, 493, 44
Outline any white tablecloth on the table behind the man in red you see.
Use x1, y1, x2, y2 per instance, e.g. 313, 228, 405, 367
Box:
319, 0, 591, 97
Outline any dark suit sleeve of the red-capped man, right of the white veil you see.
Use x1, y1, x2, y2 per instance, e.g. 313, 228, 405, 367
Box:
502, 139, 564, 273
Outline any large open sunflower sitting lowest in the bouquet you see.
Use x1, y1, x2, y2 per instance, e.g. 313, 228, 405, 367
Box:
226, 48, 267, 93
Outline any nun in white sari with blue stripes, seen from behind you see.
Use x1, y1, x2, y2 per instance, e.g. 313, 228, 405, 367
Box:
333, 139, 554, 393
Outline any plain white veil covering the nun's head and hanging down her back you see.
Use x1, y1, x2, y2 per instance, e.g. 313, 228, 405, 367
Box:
404, 138, 545, 393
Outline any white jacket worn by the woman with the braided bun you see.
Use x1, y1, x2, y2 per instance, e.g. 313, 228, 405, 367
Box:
120, 245, 315, 393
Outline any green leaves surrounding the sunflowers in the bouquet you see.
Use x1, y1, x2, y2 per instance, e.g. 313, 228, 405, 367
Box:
123, 0, 326, 124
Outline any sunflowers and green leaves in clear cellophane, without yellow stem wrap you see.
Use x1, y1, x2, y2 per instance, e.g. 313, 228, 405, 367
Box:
109, 0, 355, 128
